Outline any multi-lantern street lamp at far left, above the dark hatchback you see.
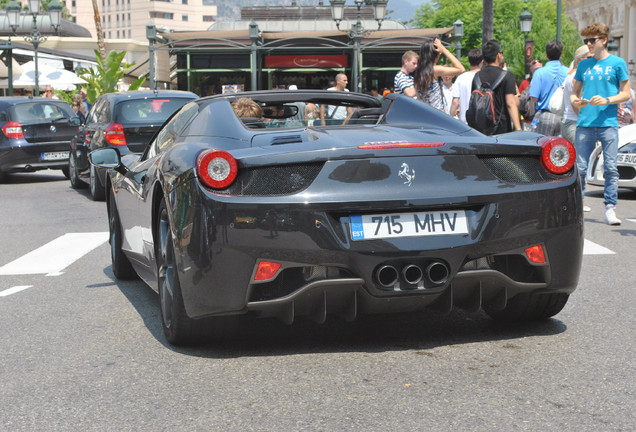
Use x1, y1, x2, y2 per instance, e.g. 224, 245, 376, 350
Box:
6, 0, 63, 96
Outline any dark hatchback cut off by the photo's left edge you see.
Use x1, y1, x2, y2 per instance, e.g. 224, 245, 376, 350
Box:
0, 96, 80, 181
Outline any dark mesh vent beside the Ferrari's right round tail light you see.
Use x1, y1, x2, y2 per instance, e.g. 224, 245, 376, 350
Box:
479, 155, 572, 184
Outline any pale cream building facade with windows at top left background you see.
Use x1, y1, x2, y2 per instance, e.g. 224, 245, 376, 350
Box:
62, 0, 217, 41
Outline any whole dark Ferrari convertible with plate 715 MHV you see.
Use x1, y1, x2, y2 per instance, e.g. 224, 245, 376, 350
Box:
90, 90, 583, 344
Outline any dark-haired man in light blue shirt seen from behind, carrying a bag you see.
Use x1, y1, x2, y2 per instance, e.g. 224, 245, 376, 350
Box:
530, 39, 568, 136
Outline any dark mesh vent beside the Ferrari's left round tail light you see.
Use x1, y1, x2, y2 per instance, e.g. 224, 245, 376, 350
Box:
214, 162, 324, 196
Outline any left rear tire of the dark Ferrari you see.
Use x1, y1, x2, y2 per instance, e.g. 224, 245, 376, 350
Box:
155, 200, 201, 345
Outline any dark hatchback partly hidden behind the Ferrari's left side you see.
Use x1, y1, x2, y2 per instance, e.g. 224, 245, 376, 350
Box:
68, 90, 198, 201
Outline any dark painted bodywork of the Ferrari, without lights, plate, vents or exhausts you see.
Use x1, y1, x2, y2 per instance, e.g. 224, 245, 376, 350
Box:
98, 93, 583, 330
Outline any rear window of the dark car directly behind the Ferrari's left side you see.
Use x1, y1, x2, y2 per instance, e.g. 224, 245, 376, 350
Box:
115, 98, 192, 124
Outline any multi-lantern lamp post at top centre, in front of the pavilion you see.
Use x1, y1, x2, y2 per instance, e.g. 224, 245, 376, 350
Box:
330, 0, 388, 92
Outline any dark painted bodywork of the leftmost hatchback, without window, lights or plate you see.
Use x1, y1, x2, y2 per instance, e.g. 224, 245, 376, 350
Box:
0, 96, 79, 176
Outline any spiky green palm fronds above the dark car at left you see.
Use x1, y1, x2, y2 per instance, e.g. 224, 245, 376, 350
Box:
79, 50, 146, 104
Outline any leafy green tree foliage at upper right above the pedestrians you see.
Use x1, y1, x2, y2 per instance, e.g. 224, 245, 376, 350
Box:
410, 0, 582, 79
